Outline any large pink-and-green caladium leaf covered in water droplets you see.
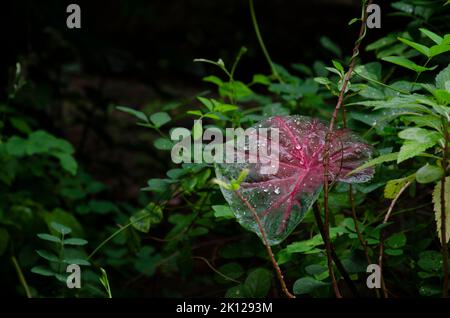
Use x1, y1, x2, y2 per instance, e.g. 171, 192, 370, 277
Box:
216, 116, 374, 245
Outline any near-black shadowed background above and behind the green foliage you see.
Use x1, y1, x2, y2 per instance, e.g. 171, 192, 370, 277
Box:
0, 0, 394, 200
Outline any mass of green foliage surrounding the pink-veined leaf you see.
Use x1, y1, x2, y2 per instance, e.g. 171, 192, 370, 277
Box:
0, 0, 450, 298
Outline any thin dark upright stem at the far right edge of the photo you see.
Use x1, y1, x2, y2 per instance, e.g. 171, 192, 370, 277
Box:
441, 119, 449, 298
